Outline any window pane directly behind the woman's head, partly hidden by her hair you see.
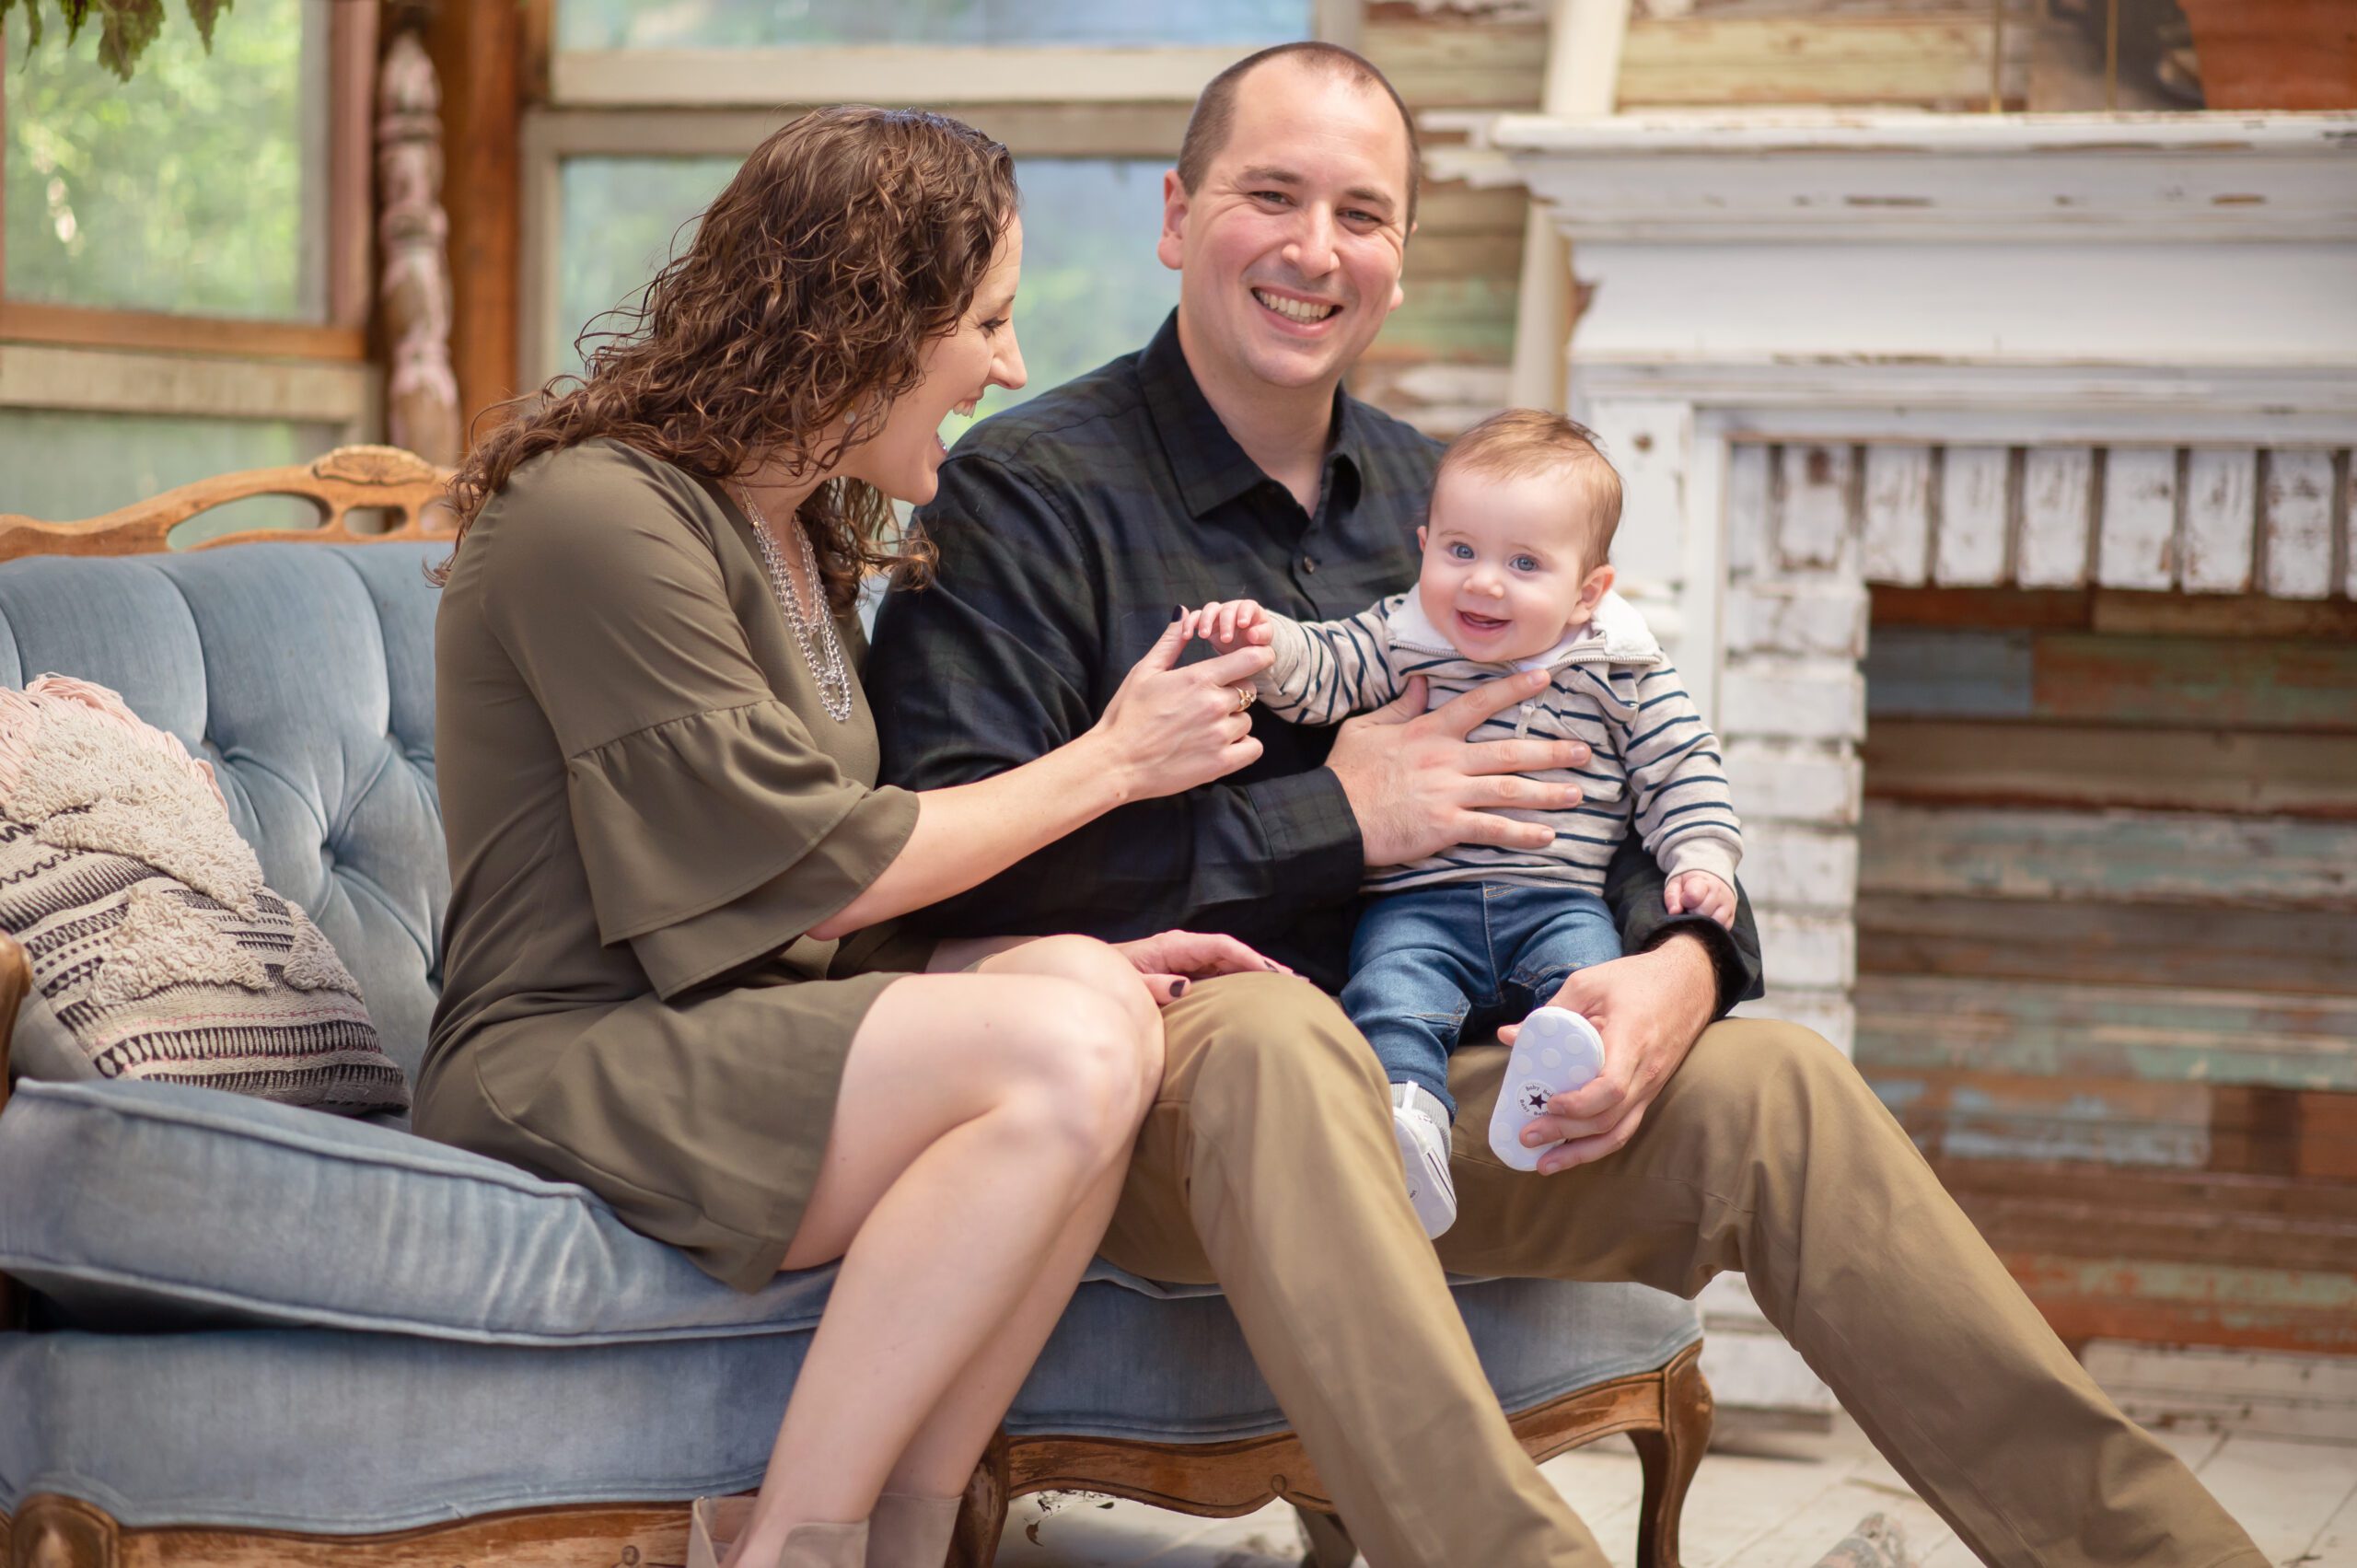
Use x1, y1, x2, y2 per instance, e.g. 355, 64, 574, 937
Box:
554, 158, 1178, 419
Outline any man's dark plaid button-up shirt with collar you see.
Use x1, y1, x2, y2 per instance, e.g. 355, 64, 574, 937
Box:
865, 316, 1759, 1007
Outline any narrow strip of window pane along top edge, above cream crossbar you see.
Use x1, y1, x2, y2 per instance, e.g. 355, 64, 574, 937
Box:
556, 0, 1310, 50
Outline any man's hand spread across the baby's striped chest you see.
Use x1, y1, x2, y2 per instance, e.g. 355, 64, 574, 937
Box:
1327, 669, 1588, 865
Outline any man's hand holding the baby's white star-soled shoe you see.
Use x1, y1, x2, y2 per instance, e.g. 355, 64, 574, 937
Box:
1499, 936, 1718, 1177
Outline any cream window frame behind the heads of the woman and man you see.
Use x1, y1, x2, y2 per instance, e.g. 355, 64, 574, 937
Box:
517, 0, 1363, 387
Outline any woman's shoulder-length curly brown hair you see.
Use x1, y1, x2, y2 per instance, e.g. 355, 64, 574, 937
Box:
431, 109, 1016, 615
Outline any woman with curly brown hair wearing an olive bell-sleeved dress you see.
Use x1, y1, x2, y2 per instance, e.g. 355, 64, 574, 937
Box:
415, 109, 1275, 1568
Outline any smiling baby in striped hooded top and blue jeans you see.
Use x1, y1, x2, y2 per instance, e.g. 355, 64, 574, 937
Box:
1190, 408, 1742, 1236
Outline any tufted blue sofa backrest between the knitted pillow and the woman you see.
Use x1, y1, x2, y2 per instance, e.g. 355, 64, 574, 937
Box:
0, 542, 450, 1077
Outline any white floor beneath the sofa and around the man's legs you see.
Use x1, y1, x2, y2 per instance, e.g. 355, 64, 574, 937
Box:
999, 1420, 2357, 1568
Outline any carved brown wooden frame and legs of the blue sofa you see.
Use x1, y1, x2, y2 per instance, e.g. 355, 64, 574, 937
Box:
0, 446, 1712, 1568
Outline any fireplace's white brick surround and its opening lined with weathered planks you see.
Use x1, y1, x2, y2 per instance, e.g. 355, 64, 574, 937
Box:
1718, 443, 2357, 1353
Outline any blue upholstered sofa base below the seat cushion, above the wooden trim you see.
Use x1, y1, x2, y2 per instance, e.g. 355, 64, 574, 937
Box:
0, 1281, 1697, 1527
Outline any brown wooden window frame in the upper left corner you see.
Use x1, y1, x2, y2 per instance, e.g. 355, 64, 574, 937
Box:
0, 5, 382, 443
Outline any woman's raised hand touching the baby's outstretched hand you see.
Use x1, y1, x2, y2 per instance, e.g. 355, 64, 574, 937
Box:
1089, 621, 1275, 799
